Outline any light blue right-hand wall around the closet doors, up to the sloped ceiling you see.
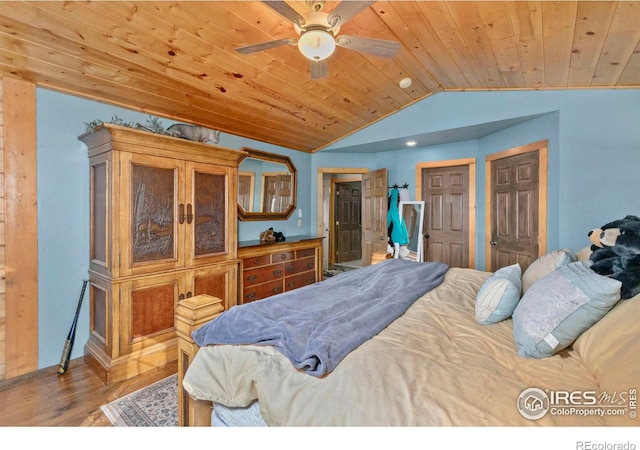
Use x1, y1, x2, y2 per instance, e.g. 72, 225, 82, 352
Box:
312, 89, 640, 269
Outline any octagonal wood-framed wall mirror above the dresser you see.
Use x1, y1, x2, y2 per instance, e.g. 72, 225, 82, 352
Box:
238, 147, 297, 221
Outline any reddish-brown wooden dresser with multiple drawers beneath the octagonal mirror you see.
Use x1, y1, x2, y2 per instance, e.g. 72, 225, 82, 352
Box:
238, 236, 323, 303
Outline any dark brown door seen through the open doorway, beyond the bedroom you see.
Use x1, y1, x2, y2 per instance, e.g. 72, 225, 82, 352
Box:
334, 181, 362, 263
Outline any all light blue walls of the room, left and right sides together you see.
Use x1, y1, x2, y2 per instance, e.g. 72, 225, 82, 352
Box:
37, 89, 640, 368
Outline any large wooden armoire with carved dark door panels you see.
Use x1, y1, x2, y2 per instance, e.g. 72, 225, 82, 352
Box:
79, 124, 245, 384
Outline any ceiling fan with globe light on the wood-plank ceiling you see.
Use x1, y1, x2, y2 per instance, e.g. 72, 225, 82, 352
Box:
236, 0, 400, 80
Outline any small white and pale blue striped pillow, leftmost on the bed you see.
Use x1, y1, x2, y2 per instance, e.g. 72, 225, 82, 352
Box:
476, 263, 522, 325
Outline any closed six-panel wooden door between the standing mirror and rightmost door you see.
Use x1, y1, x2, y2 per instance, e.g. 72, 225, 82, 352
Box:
421, 165, 472, 267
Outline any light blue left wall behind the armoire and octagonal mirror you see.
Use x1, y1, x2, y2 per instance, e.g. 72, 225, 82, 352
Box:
37, 89, 311, 368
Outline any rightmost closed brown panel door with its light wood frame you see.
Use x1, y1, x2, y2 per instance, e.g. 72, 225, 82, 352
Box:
487, 142, 546, 271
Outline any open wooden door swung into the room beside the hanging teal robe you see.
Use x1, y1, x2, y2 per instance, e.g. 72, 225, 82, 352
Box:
362, 169, 388, 266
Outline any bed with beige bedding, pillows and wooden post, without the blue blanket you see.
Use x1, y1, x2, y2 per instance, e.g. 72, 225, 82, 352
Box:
176, 250, 640, 426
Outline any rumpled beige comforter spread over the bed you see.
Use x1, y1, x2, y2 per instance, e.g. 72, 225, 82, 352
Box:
183, 268, 638, 426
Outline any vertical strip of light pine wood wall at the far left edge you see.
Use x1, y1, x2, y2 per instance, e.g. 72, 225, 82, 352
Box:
0, 77, 38, 379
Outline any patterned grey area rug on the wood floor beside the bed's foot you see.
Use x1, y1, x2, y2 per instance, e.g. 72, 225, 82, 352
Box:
100, 374, 178, 427
